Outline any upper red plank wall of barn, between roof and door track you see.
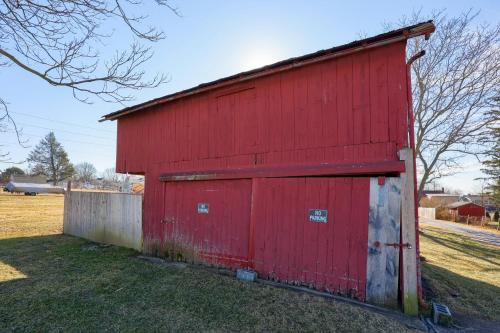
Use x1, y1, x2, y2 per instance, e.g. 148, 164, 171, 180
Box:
117, 42, 407, 173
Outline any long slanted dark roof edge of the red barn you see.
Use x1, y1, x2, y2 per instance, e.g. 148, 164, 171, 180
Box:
99, 21, 435, 121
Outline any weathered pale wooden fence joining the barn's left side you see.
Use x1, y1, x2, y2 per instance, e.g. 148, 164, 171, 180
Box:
64, 191, 142, 251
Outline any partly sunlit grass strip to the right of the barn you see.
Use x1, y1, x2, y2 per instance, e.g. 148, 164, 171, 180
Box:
420, 225, 500, 320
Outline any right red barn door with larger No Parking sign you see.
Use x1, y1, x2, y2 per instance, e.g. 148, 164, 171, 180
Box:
252, 178, 369, 299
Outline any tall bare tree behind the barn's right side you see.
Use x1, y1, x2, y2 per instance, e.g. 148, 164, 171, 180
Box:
392, 11, 500, 197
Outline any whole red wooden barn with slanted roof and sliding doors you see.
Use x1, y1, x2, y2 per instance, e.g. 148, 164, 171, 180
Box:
103, 22, 434, 312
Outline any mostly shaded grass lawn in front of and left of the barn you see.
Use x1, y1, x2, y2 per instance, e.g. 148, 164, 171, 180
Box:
0, 191, 414, 332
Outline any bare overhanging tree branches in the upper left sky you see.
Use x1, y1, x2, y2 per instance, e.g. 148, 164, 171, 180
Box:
0, 0, 178, 157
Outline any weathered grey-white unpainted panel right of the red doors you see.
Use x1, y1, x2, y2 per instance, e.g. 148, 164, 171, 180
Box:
366, 177, 401, 307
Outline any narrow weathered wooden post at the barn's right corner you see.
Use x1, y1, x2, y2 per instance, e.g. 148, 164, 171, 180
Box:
399, 148, 418, 316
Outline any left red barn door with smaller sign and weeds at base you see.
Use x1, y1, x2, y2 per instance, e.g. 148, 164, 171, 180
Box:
161, 180, 252, 267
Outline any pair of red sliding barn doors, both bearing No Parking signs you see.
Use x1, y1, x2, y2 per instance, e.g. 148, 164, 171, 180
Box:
156, 177, 369, 299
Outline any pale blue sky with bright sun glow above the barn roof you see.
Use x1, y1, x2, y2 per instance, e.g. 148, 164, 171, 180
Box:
0, 0, 500, 193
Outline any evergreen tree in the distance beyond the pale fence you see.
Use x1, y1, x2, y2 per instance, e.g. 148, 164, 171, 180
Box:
28, 132, 75, 185
